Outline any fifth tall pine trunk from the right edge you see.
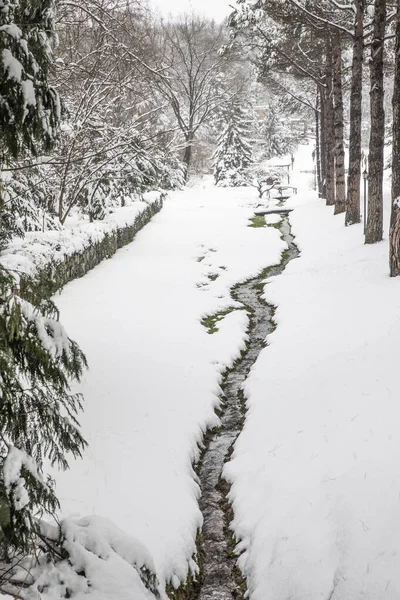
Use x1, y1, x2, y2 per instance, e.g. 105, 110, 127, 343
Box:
324, 33, 335, 206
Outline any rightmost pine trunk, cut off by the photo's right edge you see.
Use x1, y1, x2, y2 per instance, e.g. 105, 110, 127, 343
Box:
389, 0, 400, 277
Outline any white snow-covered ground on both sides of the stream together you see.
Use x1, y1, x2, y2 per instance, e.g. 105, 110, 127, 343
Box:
9, 135, 400, 600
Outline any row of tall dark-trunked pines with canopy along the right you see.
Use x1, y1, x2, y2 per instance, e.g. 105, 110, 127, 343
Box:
230, 0, 400, 274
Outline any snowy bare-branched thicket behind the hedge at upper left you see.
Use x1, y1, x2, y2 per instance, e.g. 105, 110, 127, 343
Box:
0, 0, 183, 237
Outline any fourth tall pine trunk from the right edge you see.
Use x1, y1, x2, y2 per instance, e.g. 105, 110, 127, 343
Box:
333, 33, 346, 215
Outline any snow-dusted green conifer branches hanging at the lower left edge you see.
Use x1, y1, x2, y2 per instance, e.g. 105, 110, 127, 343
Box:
0, 270, 86, 556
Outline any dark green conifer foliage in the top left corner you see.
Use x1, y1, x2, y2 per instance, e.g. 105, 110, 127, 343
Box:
0, 0, 60, 157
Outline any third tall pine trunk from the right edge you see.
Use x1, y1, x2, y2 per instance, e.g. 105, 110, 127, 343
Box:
346, 0, 366, 225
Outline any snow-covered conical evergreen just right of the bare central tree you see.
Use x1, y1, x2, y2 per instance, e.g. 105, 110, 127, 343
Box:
213, 104, 252, 187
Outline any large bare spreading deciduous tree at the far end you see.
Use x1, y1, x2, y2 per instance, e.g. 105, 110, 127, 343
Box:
142, 15, 244, 177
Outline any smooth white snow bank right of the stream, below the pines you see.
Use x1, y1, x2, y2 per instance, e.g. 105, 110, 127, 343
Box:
224, 144, 400, 600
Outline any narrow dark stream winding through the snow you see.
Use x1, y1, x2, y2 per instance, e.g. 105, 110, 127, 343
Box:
198, 216, 299, 600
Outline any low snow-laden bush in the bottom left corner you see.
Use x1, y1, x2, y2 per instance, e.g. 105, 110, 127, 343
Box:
0, 516, 160, 600
